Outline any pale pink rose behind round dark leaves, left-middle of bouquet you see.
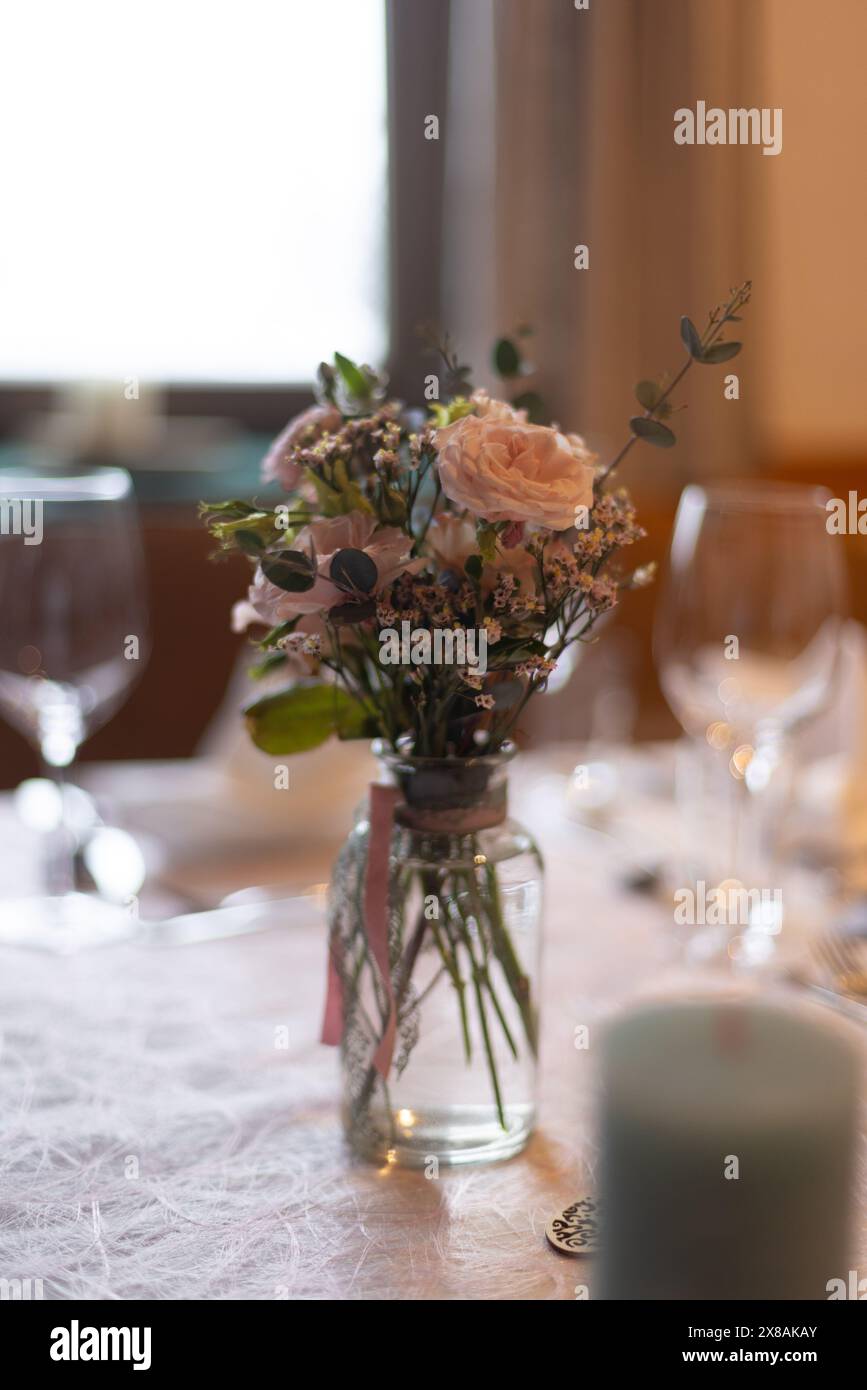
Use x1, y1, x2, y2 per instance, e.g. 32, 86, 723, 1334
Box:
247, 512, 424, 627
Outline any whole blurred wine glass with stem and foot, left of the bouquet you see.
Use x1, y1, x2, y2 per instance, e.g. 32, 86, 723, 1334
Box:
0, 464, 147, 951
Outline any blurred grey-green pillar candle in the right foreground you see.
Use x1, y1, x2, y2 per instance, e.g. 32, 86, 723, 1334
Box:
593, 999, 859, 1300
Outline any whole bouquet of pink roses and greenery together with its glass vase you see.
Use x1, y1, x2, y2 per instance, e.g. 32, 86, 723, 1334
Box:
206, 284, 749, 1166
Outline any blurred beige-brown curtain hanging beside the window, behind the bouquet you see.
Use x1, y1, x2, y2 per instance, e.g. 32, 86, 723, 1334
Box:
443, 0, 767, 493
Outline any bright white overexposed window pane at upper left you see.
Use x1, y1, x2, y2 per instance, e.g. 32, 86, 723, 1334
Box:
0, 0, 386, 382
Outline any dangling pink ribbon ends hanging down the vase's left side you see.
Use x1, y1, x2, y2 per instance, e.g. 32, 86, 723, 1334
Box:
322, 783, 400, 1077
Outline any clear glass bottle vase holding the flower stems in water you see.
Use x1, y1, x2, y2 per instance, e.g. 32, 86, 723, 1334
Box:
329, 746, 542, 1173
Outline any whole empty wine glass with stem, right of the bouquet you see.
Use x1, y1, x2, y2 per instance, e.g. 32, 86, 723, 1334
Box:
654, 480, 846, 965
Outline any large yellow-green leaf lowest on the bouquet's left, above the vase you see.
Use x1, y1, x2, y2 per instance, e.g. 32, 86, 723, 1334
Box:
243, 682, 368, 755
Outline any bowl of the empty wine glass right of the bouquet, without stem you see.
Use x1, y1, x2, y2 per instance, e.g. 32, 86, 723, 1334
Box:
654, 484, 845, 745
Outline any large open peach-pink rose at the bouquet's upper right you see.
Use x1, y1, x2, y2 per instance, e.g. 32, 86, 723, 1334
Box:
436, 413, 595, 531
